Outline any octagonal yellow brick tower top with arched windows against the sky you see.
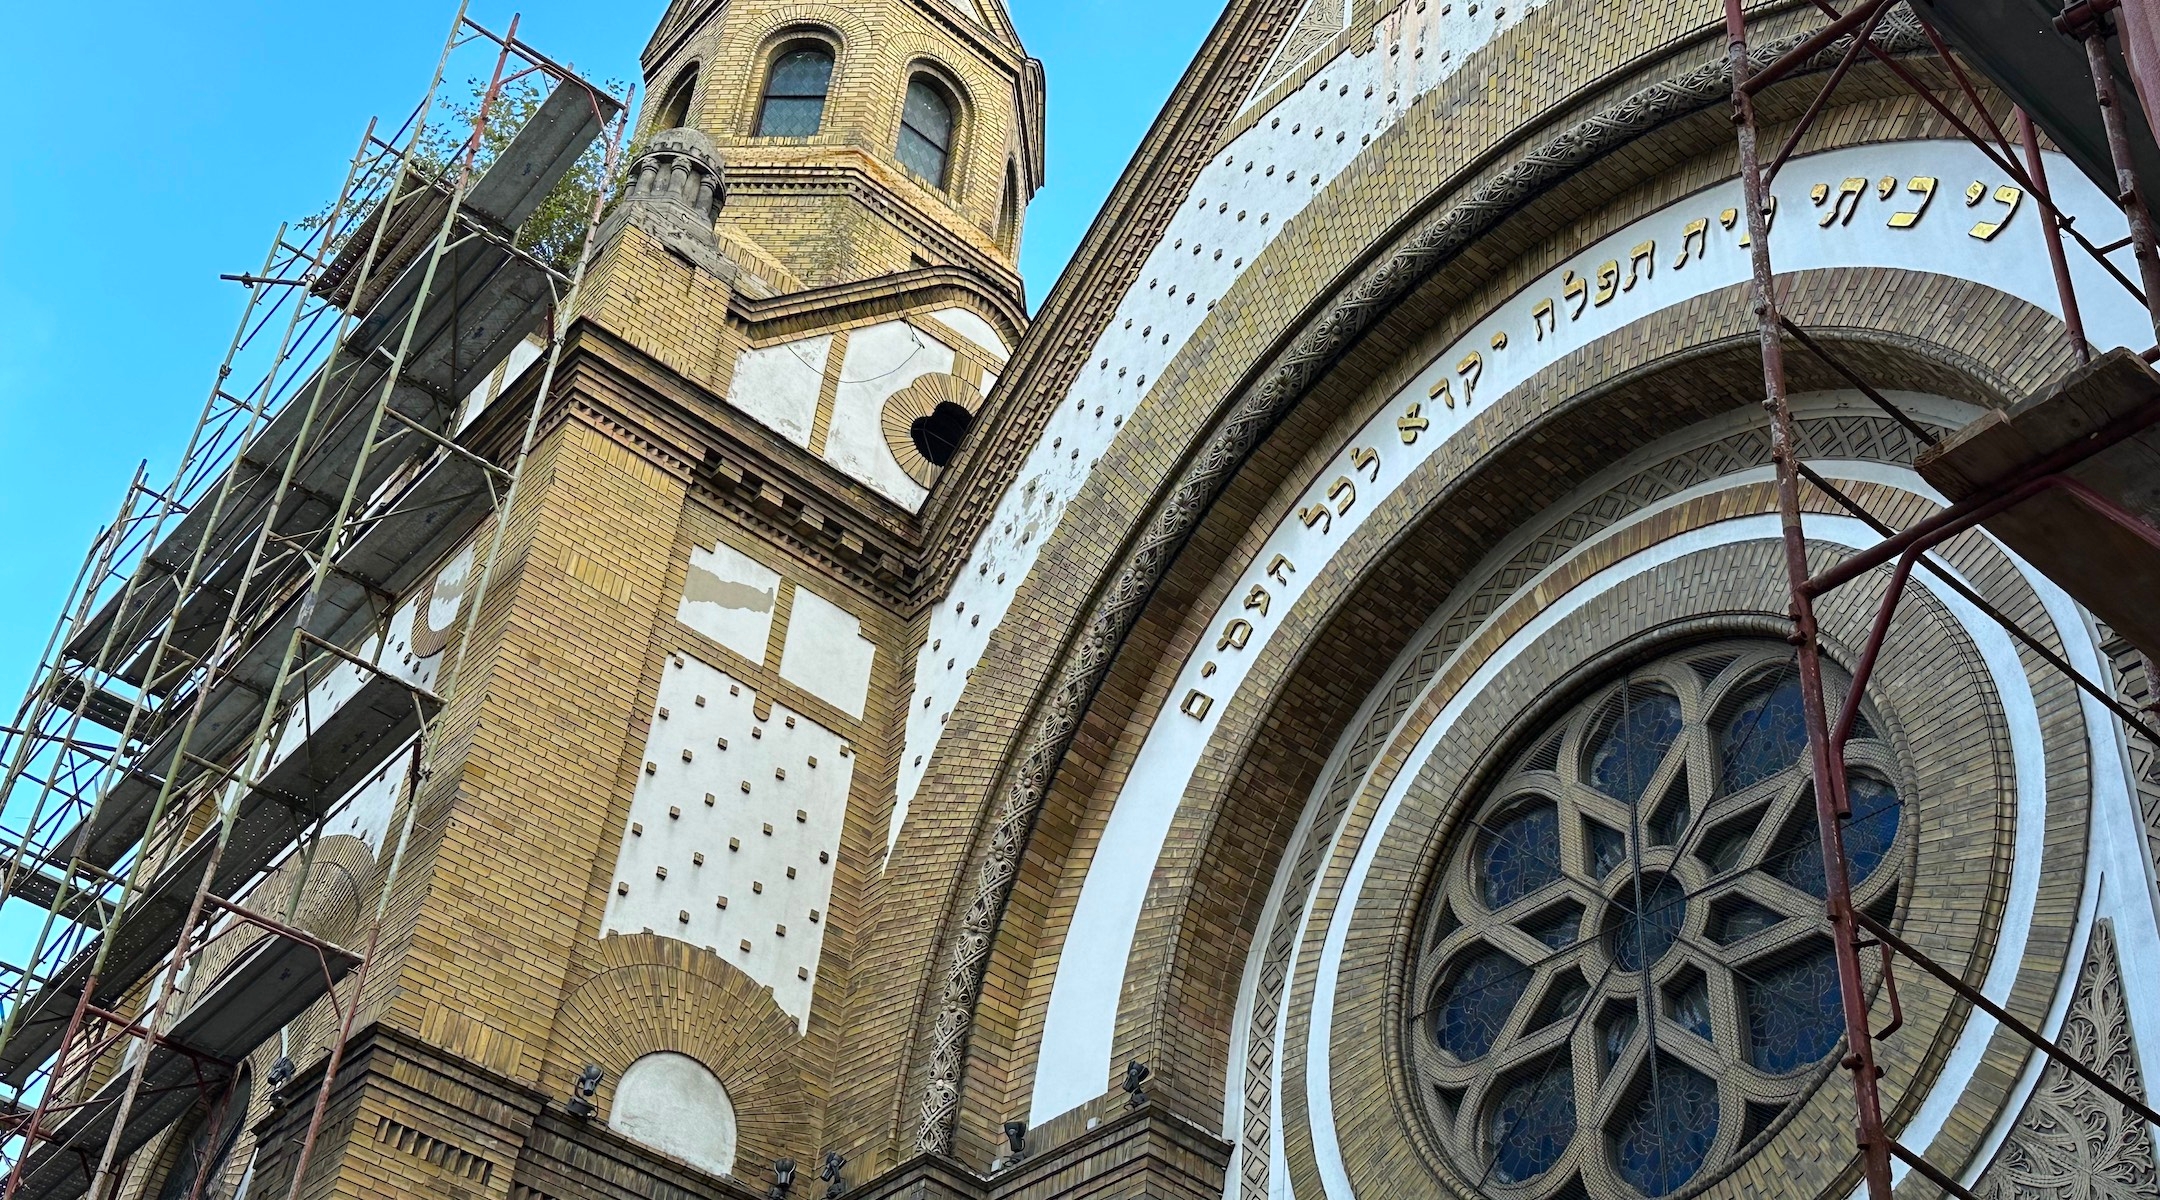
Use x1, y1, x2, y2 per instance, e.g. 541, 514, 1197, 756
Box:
639, 0, 1043, 300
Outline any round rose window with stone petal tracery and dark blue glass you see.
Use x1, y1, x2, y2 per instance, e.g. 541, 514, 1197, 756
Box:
1408, 641, 1912, 1198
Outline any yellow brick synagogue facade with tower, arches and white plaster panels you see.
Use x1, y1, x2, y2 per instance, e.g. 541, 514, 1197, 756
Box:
92, 0, 2160, 1200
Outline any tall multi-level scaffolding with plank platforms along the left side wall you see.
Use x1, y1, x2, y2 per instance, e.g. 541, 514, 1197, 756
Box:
0, 4, 631, 1200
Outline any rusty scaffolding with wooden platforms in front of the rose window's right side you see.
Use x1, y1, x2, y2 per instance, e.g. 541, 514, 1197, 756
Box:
1726, 0, 2160, 1200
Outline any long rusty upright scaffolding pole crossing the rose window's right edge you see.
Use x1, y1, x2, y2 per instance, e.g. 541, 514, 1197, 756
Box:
1726, 0, 1892, 1200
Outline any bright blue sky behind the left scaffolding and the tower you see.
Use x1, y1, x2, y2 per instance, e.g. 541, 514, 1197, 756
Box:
0, 0, 1220, 719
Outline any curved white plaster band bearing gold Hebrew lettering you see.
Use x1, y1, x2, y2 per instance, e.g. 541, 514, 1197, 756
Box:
1028, 142, 2149, 1114
